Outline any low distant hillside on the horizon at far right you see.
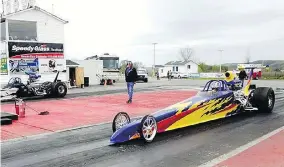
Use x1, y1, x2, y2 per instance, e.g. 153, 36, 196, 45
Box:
223, 60, 284, 70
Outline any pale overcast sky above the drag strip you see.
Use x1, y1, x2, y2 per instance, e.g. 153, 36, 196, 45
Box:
2, 0, 284, 66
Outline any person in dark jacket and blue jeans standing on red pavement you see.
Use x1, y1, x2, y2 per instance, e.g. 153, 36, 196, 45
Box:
125, 62, 137, 103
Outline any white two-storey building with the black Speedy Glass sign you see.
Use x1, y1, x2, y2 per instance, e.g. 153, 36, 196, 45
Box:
1, 6, 68, 84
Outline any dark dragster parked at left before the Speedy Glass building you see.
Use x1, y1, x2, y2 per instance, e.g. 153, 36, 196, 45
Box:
1, 71, 67, 100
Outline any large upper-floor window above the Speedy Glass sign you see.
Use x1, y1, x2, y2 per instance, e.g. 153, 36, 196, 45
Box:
8, 20, 37, 41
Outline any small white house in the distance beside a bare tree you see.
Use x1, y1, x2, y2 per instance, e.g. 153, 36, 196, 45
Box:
159, 61, 198, 77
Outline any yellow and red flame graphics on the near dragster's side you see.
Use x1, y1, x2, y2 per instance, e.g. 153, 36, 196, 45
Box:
158, 96, 238, 132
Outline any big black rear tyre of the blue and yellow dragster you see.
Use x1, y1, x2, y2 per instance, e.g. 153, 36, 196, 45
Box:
252, 87, 275, 113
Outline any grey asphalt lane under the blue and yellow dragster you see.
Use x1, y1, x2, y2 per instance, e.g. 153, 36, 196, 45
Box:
1, 80, 284, 167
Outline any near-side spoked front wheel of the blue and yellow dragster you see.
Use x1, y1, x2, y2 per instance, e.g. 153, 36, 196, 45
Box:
141, 115, 158, 143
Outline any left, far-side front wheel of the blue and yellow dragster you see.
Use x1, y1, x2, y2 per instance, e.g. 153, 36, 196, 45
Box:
112, 112, 130, 132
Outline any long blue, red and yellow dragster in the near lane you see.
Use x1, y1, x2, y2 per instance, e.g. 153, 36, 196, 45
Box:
110, 65, 275, 144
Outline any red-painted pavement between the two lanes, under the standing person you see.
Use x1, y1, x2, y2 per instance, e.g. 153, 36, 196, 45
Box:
1, 90, 197, 141
